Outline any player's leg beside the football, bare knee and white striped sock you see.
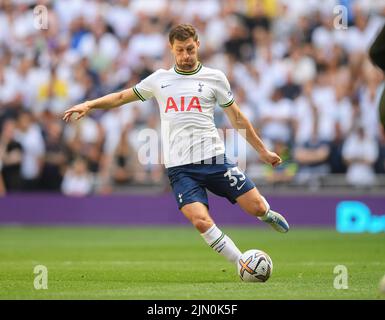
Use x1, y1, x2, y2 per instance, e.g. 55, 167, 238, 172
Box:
180, 202, 241, 264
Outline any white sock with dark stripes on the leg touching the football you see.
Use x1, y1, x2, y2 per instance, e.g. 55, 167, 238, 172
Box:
201, 224, 242, 263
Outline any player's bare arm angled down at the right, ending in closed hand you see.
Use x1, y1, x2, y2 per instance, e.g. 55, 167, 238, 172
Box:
224, 102, 282, 167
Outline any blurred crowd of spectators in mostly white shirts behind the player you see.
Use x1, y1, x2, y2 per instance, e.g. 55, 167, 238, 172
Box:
0, 0, 385, 195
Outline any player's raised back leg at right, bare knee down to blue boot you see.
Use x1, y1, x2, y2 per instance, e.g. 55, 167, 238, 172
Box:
236, 187, 289, 233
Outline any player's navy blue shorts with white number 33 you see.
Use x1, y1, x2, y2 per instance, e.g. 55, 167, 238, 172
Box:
167, 155, 255, 209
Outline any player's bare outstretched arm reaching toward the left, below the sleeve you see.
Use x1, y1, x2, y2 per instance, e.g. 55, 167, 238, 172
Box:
63, 88, 140, 122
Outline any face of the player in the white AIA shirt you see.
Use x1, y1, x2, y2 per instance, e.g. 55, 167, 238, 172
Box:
170, 38, 199, 71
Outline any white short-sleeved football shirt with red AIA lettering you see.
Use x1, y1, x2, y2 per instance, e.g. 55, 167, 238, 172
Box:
133, 63, 234, 168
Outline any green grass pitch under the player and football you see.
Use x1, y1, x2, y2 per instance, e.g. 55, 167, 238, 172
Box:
0, 226, 385, 300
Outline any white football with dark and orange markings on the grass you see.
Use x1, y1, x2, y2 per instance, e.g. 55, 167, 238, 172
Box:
237, 249, 273, 282
